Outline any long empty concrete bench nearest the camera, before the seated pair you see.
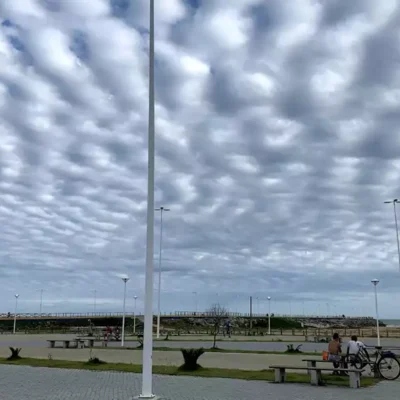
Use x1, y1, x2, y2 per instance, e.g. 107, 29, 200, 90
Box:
269, 365, 363, 389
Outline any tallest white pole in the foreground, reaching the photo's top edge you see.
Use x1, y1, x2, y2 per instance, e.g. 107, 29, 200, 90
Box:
140, 0, 155, 399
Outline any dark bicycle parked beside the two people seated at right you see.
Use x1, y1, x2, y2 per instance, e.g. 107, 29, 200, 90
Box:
346, 346, 400, 381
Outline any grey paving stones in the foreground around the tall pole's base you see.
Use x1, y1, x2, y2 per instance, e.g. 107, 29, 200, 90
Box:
0, 365, 400, 400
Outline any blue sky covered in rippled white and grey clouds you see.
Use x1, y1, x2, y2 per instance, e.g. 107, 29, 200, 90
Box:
0, 0, 400, 318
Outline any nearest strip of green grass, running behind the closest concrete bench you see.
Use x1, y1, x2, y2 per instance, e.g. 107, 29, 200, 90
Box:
0, 358, 379, 387
